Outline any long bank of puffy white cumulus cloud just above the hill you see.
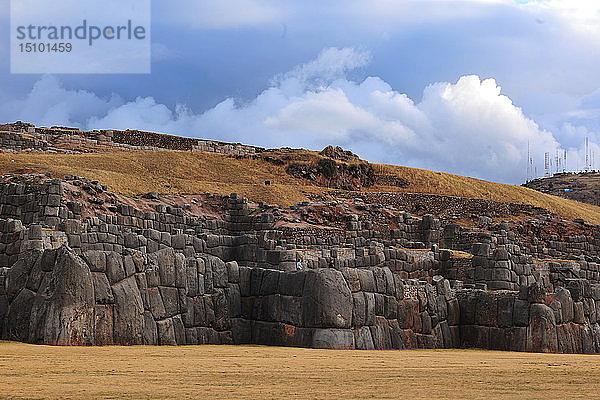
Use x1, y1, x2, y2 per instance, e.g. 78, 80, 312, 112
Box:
0, 48, 592, 183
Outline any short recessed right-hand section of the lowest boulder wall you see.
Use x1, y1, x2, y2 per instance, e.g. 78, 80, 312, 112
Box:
458, 283, 600, 353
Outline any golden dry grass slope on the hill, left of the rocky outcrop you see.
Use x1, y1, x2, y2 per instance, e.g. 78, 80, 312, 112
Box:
0, 151, 323, 205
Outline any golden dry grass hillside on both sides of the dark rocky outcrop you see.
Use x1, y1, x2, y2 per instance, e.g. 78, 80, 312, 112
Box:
0, 150, 600, 224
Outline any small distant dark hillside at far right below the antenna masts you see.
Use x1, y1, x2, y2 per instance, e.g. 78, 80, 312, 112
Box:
523, 172, 600, 206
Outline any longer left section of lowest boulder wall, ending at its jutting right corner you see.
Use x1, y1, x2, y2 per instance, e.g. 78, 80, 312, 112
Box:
0, 245, 458, 349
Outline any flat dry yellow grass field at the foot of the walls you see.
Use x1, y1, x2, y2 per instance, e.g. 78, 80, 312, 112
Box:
0, 342, 600, 400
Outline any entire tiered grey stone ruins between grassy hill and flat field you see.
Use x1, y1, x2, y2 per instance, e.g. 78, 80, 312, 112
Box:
0, 177, 600, 353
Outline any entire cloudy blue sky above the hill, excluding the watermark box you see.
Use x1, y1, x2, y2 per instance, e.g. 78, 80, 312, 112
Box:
0, 0, 600, 184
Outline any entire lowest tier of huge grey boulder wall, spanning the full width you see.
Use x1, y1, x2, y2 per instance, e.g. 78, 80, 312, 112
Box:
10, 241, 600, 353
